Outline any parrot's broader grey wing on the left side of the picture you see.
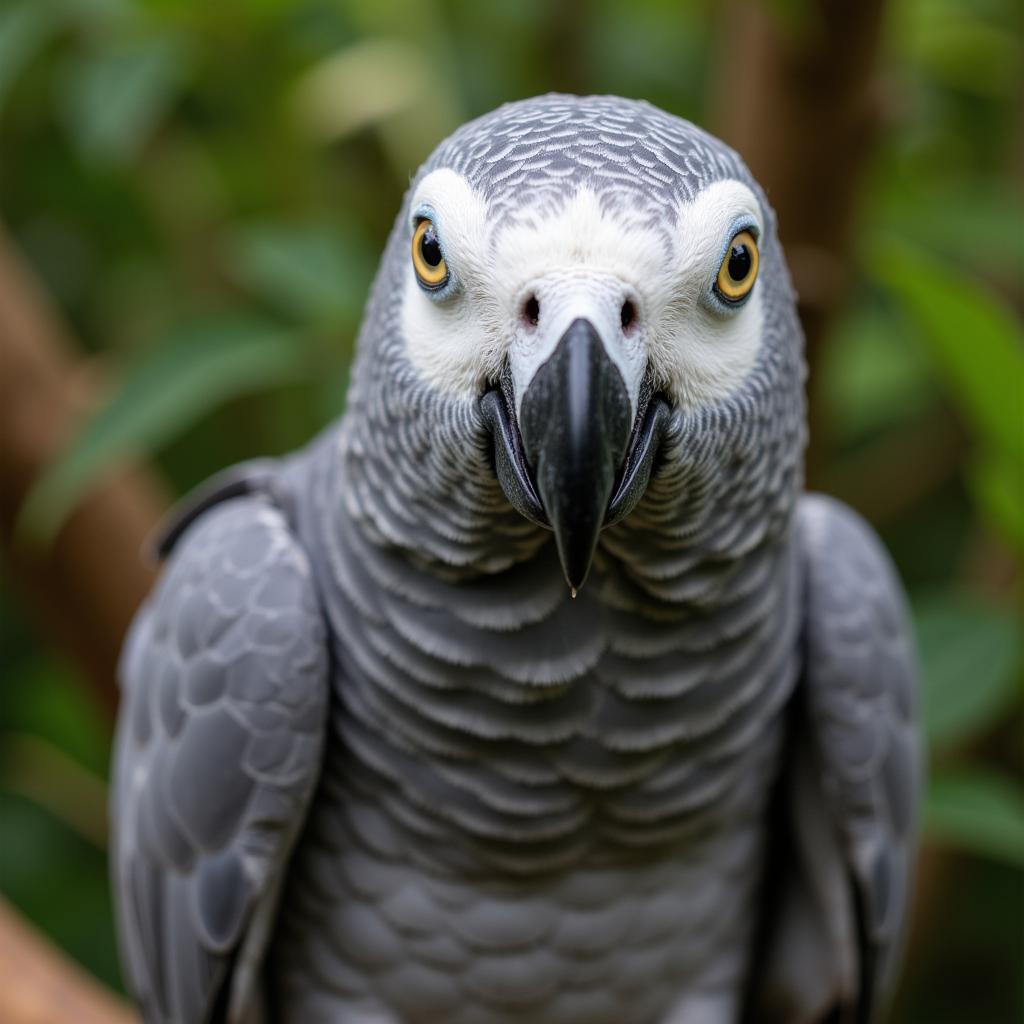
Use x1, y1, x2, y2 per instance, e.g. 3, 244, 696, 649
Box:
112, 496, 328, 1024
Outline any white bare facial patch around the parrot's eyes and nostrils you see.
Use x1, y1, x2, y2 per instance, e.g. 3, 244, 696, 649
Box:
402, 169, 762, 414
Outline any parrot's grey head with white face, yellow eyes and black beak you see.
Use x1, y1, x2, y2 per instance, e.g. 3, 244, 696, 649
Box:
339, 96, 803, 596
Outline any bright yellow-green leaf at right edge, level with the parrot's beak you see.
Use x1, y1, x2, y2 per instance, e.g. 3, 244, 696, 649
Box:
866, 234, 1024, 467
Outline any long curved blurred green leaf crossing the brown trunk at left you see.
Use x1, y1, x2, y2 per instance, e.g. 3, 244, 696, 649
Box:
17, 316, 308, 542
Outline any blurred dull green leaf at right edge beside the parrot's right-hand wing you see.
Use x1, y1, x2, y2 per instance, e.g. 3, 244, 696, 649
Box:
914, 594, 1020, 746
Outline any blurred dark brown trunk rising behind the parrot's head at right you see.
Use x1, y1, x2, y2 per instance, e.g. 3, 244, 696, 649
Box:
716, 0, 886, 485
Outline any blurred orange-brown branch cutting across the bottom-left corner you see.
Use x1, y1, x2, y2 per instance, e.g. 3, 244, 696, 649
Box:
0, 901, 137, 1024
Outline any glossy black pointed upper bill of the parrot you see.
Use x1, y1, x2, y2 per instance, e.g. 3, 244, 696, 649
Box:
519, 318, 633, 594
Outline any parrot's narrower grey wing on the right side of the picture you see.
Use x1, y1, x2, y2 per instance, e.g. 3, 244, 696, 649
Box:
752, 496, 922, 1024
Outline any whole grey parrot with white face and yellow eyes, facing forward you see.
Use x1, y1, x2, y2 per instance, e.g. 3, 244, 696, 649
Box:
113, 95, 920, 1024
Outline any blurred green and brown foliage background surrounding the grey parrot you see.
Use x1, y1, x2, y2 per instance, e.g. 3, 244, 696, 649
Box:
0, 0, 1024, 1024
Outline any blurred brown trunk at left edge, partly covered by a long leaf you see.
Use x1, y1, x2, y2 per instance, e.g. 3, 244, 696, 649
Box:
0, 227, 167, 720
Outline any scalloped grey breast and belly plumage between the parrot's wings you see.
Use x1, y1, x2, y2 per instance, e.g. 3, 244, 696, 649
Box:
269, 440, 800, 1024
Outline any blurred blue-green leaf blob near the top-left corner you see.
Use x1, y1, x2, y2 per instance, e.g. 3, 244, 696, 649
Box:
63, 37, 186, 163
